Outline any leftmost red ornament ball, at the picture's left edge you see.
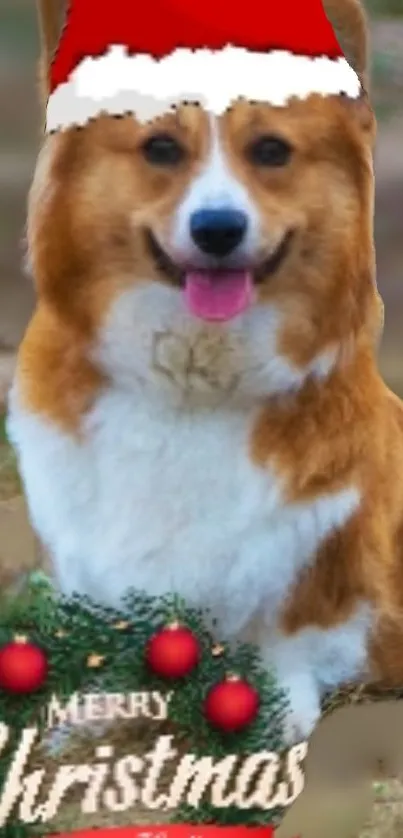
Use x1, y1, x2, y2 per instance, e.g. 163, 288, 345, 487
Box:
0, 638, 48, 695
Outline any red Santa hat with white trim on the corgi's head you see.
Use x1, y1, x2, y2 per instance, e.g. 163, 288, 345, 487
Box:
47, 0, 361, 132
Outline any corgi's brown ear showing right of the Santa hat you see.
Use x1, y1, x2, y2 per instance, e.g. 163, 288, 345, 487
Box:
323, 0, 369, 91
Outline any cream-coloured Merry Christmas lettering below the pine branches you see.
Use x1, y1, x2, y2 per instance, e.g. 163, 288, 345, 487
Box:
0, 692, 307, 828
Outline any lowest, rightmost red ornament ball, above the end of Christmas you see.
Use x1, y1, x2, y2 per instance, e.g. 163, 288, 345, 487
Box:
204, 675, 260, 733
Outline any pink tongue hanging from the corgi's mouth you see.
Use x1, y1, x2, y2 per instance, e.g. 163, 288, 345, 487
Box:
185, 271, 253, 321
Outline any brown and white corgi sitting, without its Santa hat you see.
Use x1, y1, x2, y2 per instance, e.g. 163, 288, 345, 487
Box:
8, 0, 403, 741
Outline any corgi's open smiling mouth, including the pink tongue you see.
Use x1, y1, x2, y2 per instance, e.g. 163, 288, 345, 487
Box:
145, 229, 294, 322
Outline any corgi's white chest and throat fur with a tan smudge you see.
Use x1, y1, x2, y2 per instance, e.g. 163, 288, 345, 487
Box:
10, 292, 357, 633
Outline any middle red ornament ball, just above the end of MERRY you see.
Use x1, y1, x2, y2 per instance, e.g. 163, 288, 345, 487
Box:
146, 623, 200, 678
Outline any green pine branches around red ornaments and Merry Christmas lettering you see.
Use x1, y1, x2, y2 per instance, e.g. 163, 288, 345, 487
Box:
0, 574, 286, 838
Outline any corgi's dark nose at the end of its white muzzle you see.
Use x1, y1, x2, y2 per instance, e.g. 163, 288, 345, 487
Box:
190, 209, 247, 257
